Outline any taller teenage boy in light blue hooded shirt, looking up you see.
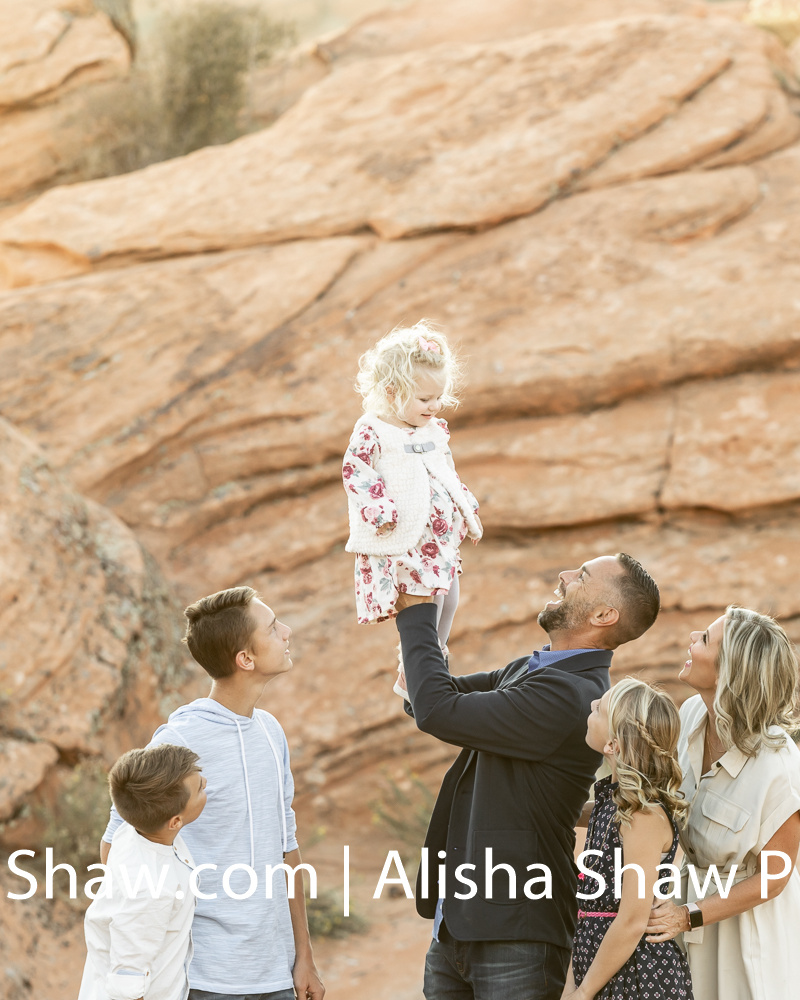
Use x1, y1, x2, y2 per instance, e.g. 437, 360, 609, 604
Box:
101, 587, 325, 1000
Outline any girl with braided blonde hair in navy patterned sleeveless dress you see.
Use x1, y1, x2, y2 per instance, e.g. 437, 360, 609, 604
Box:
562, 677, 692, 1000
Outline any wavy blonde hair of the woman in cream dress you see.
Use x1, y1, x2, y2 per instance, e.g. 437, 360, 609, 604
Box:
714, 604, 800, 757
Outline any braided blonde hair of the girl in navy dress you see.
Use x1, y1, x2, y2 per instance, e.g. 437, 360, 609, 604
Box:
608, 677, 689, 826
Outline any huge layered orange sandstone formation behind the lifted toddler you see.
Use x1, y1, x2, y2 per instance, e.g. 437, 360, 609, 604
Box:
0, 3, 800, 852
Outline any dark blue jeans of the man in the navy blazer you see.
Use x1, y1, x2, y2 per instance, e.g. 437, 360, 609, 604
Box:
423, 925, 570, 1000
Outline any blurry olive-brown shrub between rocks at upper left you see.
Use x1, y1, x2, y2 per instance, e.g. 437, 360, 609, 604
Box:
76, 0, 293, 179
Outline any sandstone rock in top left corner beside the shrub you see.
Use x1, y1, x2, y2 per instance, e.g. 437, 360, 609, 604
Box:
0, 0, 130, 203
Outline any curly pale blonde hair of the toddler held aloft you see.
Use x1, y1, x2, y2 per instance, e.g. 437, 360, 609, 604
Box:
356, 320, 462, 416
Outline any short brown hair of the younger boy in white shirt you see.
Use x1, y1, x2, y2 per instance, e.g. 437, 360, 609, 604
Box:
108, 743, 200, 833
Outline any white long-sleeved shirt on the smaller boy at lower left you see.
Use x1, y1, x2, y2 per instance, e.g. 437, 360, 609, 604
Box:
78, 823, 195, 1000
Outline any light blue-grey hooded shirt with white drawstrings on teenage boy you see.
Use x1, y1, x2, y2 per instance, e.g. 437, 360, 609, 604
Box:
103, 698, 301, 994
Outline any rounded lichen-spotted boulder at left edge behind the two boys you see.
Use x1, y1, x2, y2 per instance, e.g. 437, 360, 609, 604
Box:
0, 420, 190, 843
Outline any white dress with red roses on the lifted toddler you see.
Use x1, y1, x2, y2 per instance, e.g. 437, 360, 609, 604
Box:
342, 420, 478, 625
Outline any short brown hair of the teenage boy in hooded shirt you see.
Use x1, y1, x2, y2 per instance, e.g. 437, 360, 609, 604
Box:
183, 587, 258, 680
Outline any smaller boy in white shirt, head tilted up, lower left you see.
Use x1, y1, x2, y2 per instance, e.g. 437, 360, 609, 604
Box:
78, 743, 206, 1000
